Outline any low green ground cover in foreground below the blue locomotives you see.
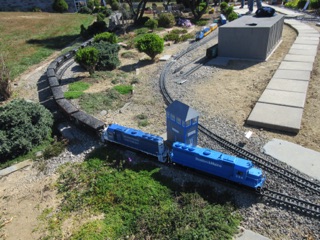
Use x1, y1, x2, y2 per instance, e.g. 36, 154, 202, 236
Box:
38, 146, 240, 240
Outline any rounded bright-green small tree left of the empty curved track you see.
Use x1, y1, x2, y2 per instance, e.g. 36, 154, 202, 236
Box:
136, 33, 164, 60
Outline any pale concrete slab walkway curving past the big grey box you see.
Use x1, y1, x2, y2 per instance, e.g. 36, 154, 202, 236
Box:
235, 4, 320, 133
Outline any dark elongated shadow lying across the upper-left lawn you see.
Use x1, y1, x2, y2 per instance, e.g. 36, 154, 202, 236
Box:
26, 34, 79, 50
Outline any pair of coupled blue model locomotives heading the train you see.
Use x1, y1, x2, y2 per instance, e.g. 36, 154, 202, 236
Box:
101, 124, 266, 191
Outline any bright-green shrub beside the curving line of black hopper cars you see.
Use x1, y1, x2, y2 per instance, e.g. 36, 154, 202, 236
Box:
75, 47, 98, 75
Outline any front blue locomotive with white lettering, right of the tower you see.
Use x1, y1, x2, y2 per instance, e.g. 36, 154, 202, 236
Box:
170, 142, 266, 190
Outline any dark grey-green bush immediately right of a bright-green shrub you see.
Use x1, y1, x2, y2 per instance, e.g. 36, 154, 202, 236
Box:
92, 41, 120, 71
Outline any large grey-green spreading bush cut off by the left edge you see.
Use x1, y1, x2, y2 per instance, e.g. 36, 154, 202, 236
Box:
0, 99, 53, 162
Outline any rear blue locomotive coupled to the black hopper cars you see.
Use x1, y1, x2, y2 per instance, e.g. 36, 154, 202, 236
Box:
101, 124, 168, 162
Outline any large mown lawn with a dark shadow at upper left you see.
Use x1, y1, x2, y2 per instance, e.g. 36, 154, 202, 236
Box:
0, 12, 94, 79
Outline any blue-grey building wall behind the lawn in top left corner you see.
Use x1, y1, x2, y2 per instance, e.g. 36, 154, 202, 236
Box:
0, 0, 76, 12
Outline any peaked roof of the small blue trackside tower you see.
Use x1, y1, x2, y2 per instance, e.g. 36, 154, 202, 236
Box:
166, 100, 199, 121
